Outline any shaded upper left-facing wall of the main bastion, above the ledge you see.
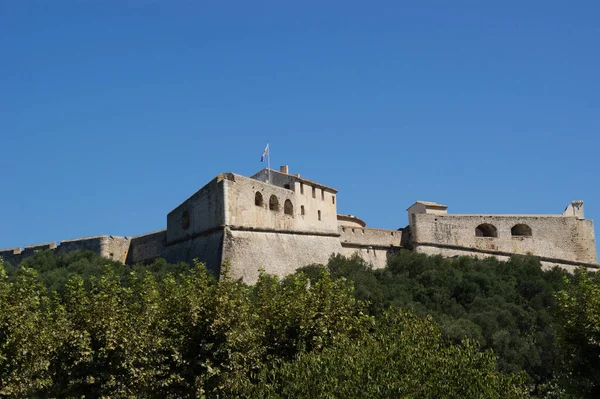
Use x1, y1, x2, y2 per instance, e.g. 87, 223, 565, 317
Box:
167, 177, 227, 243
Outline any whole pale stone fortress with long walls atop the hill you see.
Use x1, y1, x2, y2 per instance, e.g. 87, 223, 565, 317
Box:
0, 166, 600, 283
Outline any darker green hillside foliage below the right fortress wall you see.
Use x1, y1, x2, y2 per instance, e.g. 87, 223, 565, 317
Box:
302, 251, 600, 398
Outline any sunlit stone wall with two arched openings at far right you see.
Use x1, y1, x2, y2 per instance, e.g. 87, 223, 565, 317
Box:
411, 214, 597, 263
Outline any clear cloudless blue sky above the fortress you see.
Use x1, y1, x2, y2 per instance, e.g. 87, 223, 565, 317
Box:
0, 0, 600, 253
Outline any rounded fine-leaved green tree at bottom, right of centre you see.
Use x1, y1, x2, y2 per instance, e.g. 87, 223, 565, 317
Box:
253, 309, 528, 398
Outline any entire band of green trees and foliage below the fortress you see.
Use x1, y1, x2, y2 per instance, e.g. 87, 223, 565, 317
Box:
0, 252, 600, 398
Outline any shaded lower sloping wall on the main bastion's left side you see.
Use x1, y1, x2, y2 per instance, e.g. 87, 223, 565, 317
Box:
161, 229, 223, 276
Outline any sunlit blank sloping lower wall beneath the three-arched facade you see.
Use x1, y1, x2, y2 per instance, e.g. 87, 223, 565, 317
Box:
223, 228, 342, 284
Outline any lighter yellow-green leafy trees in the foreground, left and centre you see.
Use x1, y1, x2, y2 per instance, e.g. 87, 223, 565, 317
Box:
0, 254, 526, 398
